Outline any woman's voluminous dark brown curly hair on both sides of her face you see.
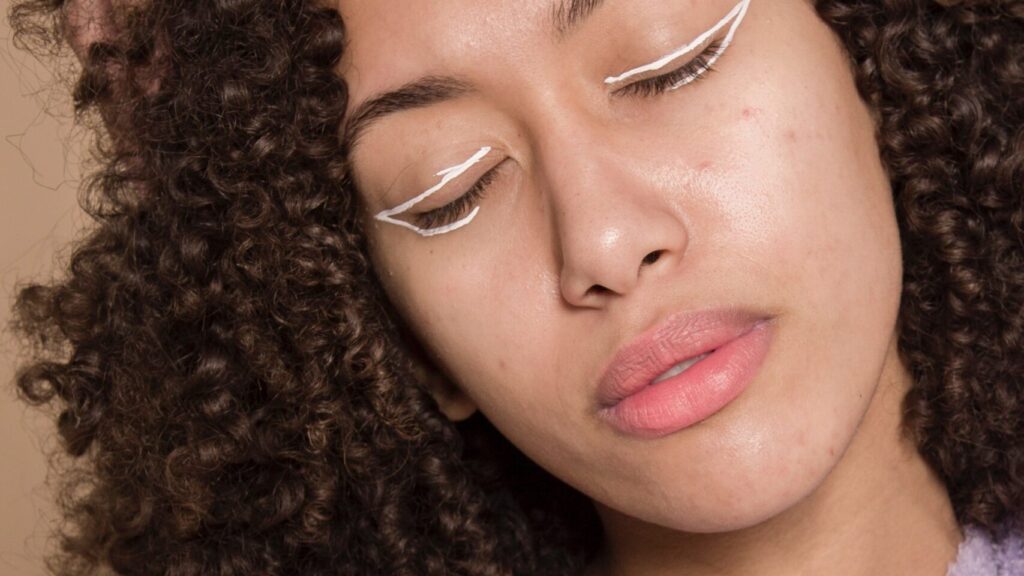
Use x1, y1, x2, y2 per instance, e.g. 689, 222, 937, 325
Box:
10, 0, 1024, 576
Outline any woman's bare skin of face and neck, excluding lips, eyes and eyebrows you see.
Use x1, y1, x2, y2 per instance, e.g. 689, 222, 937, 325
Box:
339, 0, 958, 574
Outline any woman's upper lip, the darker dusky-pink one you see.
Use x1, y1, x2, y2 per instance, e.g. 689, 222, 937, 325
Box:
597, 310, 766, 407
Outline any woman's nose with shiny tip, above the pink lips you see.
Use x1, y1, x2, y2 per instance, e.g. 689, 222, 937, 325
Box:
541, 122, 687, 307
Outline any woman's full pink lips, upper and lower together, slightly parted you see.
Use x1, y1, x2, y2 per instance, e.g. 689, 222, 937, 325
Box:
597, 310, 772, 438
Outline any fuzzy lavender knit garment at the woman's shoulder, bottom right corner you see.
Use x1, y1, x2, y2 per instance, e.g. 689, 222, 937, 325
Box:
946, 523, 1024, 576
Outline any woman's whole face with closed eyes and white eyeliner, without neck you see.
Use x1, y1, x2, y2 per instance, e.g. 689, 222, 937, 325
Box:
340, 0, 901, 532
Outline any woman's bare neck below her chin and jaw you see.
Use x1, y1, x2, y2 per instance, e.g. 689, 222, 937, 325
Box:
588, 340, 964, 576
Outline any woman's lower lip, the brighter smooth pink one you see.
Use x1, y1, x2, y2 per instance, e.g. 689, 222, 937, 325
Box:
600, 321, 771, 438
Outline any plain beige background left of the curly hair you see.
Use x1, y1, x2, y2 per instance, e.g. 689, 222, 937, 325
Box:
0, 0, 88, 576
